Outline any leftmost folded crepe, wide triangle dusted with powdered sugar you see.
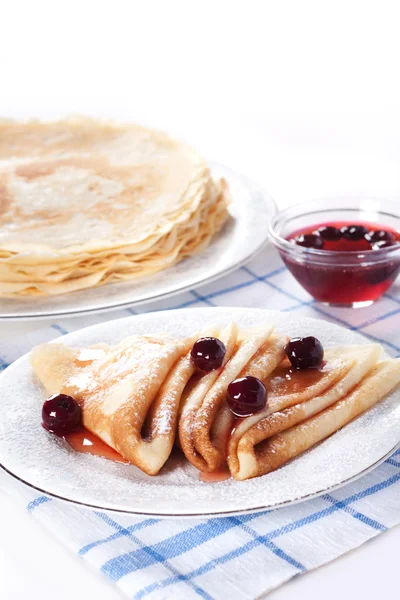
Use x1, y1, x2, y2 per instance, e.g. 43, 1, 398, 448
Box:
31, 336, 194, 475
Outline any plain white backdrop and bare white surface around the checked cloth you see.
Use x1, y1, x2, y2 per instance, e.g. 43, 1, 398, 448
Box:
0, 0, 400, 600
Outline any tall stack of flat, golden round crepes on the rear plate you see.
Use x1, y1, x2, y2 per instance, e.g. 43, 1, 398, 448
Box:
0, 119, 229, 296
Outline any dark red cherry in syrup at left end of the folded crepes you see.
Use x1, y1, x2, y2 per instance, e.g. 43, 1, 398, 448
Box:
42, 394, 82, 436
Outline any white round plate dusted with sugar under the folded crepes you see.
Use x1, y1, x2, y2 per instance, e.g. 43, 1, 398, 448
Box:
0, 308, 400, 517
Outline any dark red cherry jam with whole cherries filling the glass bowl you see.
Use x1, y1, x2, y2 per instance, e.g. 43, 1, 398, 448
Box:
281, 221, 400, 306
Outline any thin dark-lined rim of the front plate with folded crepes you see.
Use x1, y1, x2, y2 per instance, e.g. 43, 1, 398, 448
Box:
0, 306, 400, 519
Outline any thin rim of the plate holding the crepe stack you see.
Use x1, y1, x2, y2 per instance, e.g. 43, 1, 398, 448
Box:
0, 160, 278, 322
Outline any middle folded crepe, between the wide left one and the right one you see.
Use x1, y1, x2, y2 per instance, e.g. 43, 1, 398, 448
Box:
179, 325, 287, 472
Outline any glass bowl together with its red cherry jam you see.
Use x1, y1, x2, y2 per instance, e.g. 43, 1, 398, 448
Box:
269, 198, 400, 307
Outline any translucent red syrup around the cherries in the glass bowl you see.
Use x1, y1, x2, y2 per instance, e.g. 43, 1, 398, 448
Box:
281, 221, 400, 306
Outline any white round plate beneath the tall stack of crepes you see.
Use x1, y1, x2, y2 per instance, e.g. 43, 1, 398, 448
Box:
0, 163, 276, 320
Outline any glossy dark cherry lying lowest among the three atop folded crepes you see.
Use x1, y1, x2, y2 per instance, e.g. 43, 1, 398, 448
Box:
226, 376, 267, 417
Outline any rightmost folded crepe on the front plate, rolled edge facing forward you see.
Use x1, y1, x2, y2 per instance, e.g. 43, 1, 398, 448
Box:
228, 344, 390, 480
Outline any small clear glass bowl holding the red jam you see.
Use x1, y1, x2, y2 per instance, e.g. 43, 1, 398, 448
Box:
269, 197, 400, 307
